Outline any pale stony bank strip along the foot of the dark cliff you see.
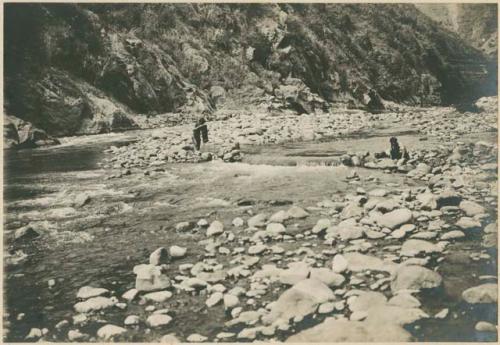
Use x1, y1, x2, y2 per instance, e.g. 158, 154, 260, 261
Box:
97, 98, 497, 170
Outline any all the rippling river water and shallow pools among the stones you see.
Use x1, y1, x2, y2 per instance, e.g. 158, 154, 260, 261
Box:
4, 127, 497, 341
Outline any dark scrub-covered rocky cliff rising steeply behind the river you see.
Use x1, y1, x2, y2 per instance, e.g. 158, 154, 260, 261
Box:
4, 4, 496, 135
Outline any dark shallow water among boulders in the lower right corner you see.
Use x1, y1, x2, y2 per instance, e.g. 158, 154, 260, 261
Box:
408, 223, 498, 342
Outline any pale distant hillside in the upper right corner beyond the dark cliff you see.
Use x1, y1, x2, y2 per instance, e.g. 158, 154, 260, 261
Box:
415, 4, 498, 59
